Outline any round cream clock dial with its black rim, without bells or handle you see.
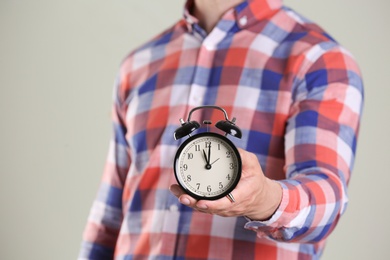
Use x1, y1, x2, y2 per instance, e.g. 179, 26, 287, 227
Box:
174, 133, 241, 200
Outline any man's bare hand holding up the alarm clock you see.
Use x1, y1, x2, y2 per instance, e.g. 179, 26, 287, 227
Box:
170, 149, 282, 220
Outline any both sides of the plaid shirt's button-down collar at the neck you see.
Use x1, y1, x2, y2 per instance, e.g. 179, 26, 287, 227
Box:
183, 0, 282, 31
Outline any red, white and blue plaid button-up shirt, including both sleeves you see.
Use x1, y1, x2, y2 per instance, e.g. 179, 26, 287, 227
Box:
79, 0, 363, 259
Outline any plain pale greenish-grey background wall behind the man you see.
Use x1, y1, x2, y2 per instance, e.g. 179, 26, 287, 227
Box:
0, 0, 390, 260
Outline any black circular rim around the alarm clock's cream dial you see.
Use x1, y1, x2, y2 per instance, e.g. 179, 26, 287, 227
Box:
173, 132, 242, 200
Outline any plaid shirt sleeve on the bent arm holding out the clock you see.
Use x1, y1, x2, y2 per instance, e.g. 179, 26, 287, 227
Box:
245, 44, 363, 243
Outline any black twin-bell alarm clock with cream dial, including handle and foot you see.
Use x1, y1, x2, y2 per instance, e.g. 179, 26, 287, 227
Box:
173, 106, 242, 202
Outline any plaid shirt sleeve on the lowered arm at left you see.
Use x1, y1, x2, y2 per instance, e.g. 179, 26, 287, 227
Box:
79, 76, 131, 259
